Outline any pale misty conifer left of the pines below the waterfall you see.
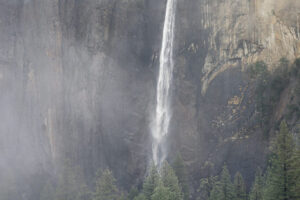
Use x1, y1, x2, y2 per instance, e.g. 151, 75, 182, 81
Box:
93, 169, 120, 200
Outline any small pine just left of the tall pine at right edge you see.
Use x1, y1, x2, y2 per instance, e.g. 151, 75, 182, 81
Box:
249, 168, 264, 200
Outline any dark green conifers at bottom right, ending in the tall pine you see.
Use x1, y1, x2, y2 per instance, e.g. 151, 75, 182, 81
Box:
198, 121, 300, 200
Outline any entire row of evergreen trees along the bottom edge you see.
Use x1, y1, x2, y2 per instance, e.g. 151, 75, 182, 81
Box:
0, 121, 300, 200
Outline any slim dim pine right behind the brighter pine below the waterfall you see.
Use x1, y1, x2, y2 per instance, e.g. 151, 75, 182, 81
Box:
173, 153, 190, 200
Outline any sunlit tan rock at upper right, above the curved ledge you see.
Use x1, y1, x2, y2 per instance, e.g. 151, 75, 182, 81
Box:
201, 0, 300, 94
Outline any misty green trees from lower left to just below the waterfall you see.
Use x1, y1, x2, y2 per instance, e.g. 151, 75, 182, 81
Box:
40, 155, 189, 200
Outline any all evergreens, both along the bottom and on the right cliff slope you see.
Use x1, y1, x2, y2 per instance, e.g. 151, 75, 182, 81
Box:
0, 59, 300, 200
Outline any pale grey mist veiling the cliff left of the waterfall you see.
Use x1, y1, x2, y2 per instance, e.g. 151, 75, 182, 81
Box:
0, 0, 155, 199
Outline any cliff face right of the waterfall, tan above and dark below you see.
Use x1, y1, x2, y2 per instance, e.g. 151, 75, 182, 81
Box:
172, 0, 300, 186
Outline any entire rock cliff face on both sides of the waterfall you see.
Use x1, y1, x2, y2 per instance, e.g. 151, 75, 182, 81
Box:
0, 0, 300, 197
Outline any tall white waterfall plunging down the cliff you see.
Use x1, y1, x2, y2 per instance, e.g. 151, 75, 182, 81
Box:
152, 0, 177, 167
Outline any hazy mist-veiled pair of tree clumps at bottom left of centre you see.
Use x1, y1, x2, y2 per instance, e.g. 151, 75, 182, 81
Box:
40, 166, 126, 200
